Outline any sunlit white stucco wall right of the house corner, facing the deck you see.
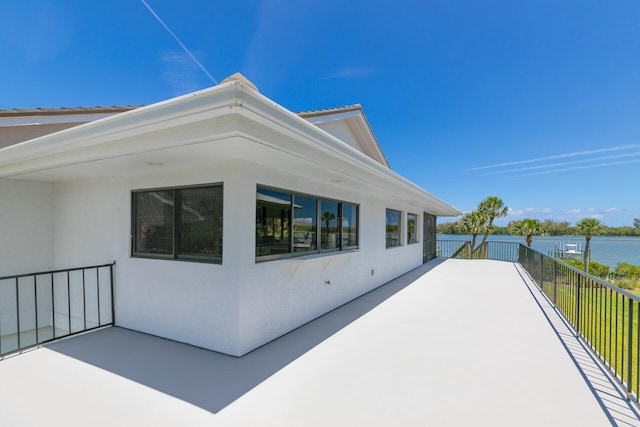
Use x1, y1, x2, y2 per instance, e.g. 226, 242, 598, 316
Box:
232, 165, 422, 352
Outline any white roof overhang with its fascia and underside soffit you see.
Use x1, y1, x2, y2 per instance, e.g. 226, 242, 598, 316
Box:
0, 81, 460, 216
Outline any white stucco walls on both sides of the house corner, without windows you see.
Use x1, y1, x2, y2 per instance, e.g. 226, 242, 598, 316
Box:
47, 161, 422, 355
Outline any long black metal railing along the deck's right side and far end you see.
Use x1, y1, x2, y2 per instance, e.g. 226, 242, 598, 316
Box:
437, 240, 640, 404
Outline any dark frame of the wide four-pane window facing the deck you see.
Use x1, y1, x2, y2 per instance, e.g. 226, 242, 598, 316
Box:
254, 184, 360, 262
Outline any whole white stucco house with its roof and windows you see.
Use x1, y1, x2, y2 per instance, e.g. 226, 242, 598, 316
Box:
0, 75, 459, 356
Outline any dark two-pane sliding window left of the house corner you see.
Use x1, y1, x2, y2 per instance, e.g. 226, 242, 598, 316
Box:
132, 184, 222, 262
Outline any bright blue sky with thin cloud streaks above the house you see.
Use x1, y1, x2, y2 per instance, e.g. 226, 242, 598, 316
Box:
0, 0, 640, 226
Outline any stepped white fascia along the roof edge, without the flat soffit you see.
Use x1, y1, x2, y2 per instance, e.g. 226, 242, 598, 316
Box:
0, 81, 460, 216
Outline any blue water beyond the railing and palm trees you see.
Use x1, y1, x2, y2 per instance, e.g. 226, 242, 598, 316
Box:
438, 234, 640, 269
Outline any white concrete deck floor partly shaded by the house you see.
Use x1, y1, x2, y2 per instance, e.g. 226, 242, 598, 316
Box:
0, 260, 640, 427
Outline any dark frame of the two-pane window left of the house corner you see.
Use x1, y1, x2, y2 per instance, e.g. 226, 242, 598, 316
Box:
130, 182, 224, 264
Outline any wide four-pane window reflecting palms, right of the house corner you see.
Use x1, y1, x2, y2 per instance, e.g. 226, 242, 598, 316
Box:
256, 187, 358, 260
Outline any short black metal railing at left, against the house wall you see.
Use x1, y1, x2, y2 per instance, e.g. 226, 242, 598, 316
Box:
0, 262, 115, 356
